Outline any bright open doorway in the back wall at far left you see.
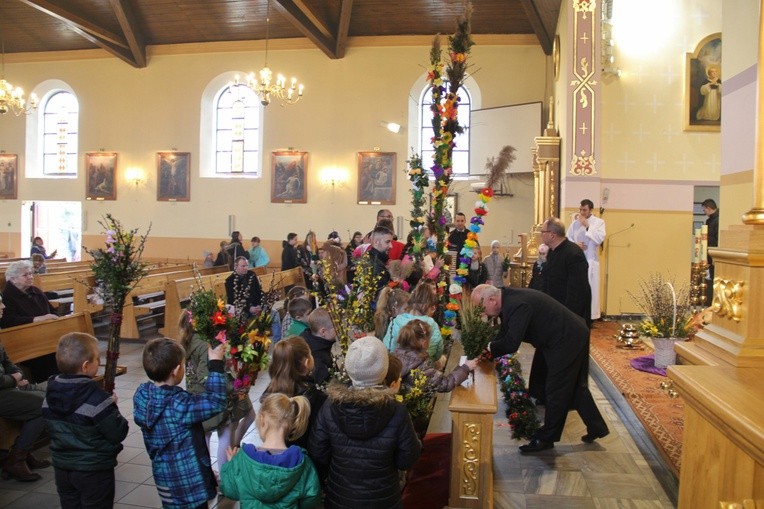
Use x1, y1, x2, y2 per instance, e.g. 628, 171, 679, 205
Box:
19, 201, 82, 262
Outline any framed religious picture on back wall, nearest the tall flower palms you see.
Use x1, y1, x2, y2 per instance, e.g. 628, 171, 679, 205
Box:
358, 152, 396, 205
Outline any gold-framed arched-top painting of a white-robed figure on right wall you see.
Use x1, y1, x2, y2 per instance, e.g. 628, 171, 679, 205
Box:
683, 33, 722, 132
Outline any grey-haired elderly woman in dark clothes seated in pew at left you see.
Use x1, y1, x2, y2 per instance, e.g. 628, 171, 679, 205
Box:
0, 260, 58, 382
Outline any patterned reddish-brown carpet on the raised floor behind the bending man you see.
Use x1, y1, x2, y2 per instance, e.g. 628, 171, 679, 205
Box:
590, 322, 684, 477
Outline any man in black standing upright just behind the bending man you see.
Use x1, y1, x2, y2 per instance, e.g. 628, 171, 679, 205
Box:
528, 217, 592, 404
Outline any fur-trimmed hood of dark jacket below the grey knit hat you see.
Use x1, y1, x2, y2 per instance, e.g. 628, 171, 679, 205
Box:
326, 384, 396, 440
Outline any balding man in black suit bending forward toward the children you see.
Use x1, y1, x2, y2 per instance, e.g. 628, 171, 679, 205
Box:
471, 285, 610, 453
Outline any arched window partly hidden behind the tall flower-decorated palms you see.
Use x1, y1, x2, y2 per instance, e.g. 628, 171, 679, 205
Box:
418, 81, 473, 176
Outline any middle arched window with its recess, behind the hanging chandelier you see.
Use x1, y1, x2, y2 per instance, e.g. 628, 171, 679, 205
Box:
199, 72, 263, 178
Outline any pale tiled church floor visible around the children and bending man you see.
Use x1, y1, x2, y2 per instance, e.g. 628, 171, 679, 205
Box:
0, 328, 674, 509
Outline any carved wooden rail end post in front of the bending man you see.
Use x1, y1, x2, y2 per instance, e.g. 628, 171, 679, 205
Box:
448, 362, 499, 509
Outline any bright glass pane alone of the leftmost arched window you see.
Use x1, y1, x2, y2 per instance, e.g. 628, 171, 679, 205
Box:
42, 90, 79, 177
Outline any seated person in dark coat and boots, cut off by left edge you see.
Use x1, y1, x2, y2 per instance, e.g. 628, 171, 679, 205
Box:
0, 299, 50, 481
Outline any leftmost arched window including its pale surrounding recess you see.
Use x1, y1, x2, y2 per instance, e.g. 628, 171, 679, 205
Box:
24, 80, 80, 178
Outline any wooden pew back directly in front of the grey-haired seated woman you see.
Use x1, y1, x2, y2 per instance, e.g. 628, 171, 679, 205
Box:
0, 313, 103, 449
